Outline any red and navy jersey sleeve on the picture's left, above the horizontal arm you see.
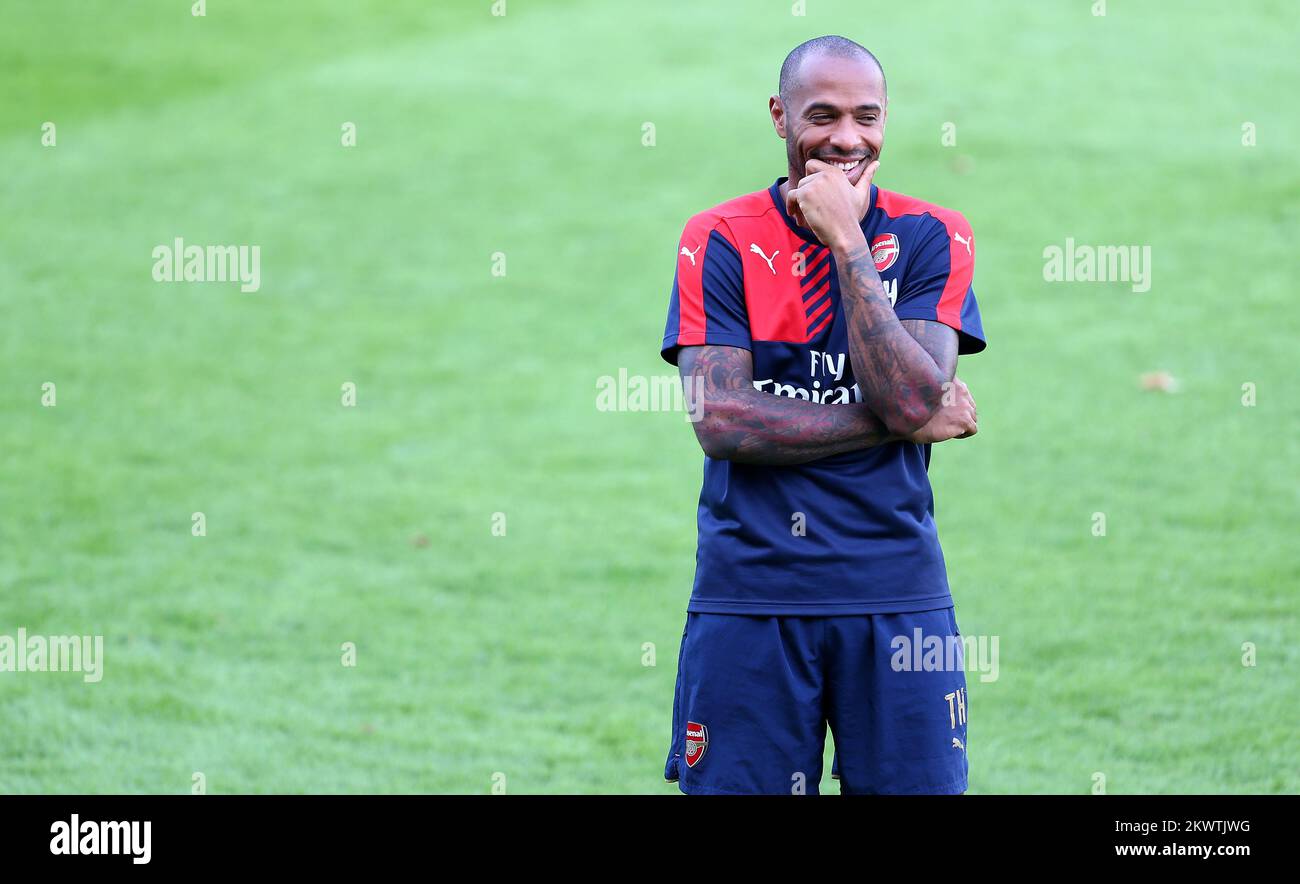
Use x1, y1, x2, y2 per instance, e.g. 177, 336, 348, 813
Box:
659, 215, 753, 365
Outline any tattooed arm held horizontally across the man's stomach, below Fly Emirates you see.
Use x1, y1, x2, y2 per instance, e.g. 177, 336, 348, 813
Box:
677, 346, 896, 465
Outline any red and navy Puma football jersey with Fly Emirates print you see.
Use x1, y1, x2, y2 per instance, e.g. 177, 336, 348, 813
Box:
660, 178, 984, 615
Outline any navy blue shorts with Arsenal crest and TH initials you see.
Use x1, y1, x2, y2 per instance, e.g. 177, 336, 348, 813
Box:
664, 607, 967, 794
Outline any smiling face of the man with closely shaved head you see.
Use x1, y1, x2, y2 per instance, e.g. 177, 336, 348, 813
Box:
768, 55, 885, 185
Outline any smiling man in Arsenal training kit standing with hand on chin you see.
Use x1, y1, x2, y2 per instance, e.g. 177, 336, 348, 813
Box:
662, 36, 984, 794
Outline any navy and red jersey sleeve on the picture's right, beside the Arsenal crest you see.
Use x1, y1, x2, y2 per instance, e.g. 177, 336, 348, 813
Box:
894, 212, 987, 355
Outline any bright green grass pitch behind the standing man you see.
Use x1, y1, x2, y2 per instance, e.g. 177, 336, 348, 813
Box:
0, 0, 1300, 793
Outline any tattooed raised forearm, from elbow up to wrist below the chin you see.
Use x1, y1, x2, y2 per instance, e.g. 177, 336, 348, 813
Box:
836, 243, 957, 436
